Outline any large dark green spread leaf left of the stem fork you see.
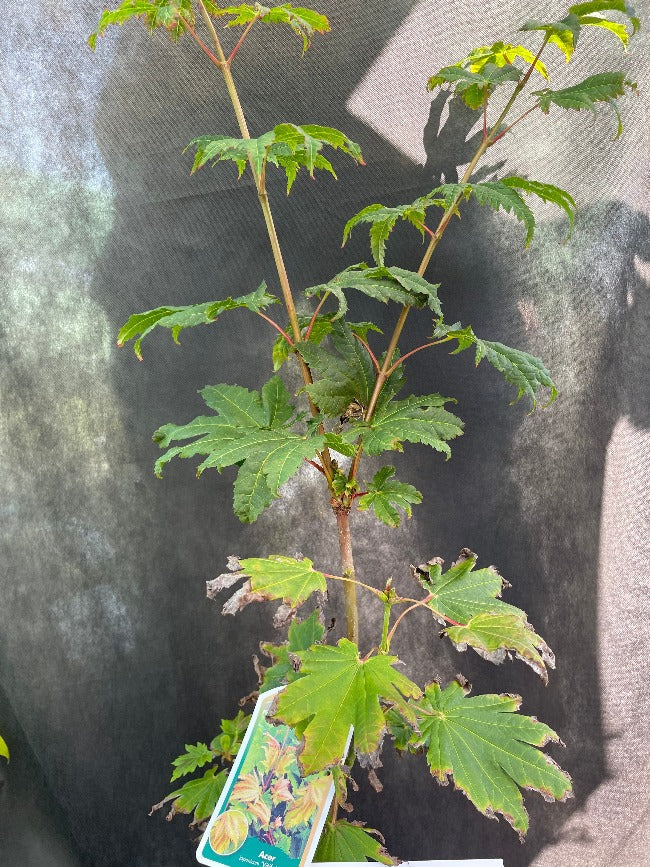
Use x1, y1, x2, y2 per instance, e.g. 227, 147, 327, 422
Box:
154, 377, 324, 523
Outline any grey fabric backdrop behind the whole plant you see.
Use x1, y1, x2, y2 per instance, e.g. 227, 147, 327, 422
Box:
0, 0, 650, 867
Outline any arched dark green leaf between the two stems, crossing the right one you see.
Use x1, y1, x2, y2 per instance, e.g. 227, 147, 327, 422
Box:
305, 262, 440, 317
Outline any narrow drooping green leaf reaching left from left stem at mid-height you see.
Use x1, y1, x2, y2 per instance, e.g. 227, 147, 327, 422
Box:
117, 282, 279, 361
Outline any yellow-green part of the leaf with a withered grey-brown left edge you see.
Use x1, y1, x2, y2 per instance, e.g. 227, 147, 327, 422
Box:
240, 555, 327, 608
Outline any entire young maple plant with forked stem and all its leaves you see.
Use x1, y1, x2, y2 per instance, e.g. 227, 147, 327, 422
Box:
87, 0, 639, 864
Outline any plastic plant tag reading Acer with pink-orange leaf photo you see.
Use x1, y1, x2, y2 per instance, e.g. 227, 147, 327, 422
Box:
196, 687, 343, 867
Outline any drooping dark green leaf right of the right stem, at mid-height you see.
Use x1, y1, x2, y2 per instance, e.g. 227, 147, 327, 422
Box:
432, 321, 558, 409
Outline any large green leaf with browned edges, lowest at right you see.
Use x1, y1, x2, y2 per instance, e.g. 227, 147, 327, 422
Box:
416, 681, 571, 836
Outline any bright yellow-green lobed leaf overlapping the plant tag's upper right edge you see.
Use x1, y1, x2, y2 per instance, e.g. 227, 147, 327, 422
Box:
275, 638, 421, 774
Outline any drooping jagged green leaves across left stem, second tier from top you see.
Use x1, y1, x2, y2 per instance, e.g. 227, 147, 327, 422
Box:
186, 123, 363, 193
